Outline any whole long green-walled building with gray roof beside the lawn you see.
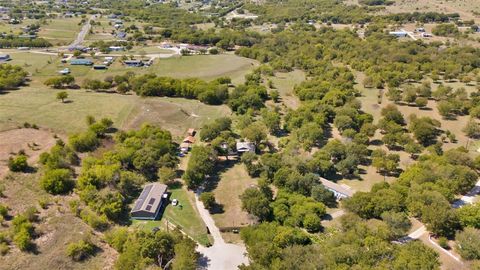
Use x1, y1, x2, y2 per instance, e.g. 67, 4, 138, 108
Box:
130, 183, 168, 220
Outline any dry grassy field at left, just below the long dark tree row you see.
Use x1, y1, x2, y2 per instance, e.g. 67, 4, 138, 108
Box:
0, 86, 230, 137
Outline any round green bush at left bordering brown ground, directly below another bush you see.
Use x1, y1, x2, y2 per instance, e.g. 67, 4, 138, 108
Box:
40, 169, 73, 194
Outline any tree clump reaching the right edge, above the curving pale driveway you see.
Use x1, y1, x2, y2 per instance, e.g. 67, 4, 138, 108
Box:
343, 148, 478, 237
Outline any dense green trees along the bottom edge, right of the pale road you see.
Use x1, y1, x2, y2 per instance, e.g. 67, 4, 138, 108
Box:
241, 214, 440, 269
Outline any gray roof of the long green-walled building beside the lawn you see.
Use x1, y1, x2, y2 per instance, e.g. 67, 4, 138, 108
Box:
131, 183, 167, 213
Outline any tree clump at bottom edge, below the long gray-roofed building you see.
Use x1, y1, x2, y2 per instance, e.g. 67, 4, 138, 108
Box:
106, 227, 199, 270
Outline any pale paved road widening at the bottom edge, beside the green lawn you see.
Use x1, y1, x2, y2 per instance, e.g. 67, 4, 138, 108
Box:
195, 191, 248, 270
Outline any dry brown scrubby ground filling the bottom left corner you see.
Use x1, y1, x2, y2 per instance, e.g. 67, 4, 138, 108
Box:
0, 174, 117, 270
